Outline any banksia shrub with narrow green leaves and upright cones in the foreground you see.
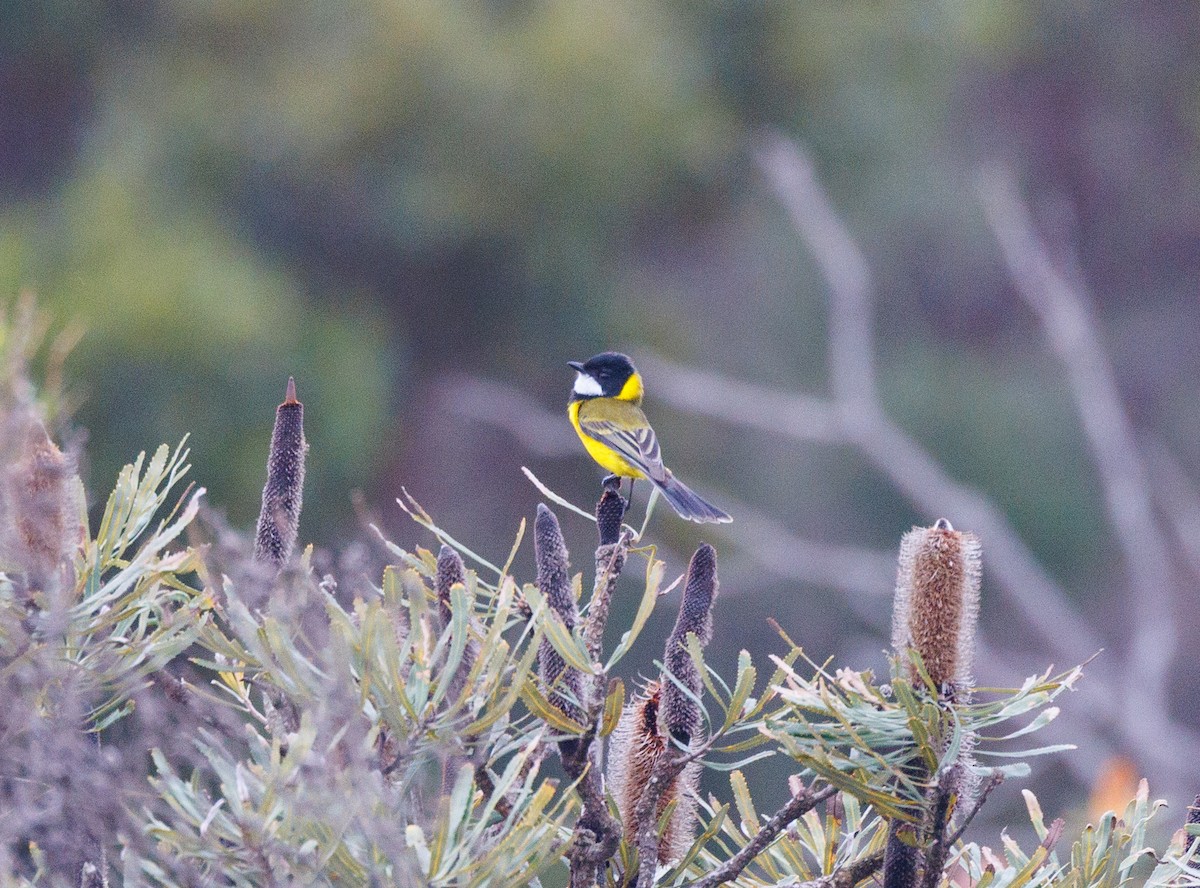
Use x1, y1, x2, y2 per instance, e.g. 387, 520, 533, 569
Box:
0, 300, 1196, 888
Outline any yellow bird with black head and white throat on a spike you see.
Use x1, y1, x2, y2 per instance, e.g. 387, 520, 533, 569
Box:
566, 352, 733, 524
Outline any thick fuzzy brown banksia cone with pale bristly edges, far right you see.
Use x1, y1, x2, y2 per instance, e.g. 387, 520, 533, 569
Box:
892, 518, 980, 700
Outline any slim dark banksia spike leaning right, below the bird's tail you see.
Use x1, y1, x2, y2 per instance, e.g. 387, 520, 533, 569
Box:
662, 542, 718, 745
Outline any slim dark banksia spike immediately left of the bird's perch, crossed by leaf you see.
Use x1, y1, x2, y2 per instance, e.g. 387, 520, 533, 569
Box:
533, 503, 583, 721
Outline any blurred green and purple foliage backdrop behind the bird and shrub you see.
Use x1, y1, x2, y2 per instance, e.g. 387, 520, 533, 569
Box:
0, 0, 1200, 825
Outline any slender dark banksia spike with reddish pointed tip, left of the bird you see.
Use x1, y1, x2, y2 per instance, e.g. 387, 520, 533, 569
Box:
254, 378, 308, 566
